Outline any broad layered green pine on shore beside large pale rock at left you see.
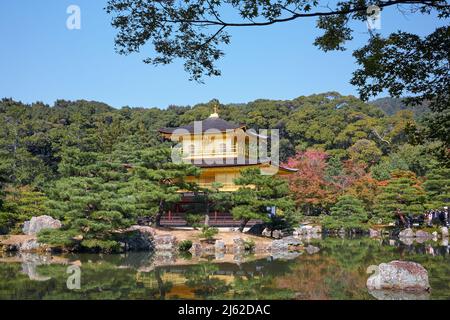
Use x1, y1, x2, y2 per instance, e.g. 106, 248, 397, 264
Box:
43, 151, 137, 251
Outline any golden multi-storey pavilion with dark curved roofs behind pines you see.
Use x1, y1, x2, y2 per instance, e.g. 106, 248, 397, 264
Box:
159, 108, 296, 225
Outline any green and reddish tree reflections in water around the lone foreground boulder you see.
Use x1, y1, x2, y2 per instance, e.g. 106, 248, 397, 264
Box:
277, 238, 450, 299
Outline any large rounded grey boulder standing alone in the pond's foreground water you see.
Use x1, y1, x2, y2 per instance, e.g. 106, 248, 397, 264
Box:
367, 260, 430, 292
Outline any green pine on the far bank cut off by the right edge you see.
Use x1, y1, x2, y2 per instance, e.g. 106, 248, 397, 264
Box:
423, 168, 450, 209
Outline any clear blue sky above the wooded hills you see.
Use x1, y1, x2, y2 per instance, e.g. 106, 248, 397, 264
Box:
0, 0, 443, 108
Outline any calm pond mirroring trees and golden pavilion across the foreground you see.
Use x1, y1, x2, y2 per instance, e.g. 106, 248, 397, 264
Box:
0, 238, 450, 299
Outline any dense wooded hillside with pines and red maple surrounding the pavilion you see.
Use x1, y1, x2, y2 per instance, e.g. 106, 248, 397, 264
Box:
0, 92, 450, 250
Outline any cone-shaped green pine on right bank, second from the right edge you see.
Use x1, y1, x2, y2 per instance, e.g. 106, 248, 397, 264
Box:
375, 171, 426, 222
